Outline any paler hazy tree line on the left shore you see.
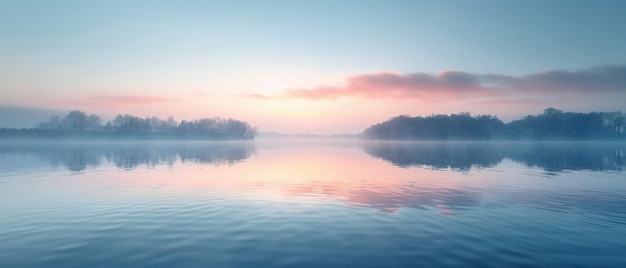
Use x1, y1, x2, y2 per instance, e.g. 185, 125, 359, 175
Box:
0, 110, 257, 140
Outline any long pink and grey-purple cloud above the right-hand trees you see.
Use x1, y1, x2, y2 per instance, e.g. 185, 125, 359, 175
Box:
245, 66, 626, 100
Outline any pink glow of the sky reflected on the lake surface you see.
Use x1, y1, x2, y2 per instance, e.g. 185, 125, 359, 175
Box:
85, 143, 481, 215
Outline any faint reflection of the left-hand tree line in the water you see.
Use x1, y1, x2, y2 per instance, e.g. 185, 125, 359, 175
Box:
0, 142, 256, 171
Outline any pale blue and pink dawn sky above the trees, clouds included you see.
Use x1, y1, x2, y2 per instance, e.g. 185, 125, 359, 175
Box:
0, 0, 626, 134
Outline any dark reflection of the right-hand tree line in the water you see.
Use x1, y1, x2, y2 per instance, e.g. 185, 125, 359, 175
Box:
362, 142, 626, 171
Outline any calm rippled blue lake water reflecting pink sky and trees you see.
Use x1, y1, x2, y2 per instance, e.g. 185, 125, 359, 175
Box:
0, 141, 626, 267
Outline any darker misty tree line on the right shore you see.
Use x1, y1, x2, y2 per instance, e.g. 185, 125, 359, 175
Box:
362, 108, 626, 140
